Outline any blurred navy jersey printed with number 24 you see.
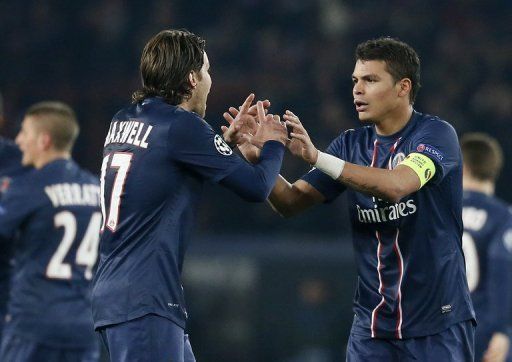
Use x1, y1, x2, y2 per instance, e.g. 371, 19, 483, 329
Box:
0, 159, 101, 347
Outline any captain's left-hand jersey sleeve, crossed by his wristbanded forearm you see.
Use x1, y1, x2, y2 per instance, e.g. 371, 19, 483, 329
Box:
301, 133, 347, 202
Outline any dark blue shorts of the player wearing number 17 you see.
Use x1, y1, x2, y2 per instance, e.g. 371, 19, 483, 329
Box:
99, 314, 196, 362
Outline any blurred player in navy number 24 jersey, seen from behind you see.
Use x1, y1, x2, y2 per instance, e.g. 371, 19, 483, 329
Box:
0, 102, 101, 362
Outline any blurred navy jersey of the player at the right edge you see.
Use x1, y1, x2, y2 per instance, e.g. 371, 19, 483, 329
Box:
462, 191, 512, 333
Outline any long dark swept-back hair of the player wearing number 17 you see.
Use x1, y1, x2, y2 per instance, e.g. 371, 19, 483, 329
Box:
132, 30, 206, 105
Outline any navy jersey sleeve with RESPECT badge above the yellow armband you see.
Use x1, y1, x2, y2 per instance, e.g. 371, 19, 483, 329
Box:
410, 120, 462, 184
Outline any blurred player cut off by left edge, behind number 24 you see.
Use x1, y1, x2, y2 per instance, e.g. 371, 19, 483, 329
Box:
0, 93, 28, 340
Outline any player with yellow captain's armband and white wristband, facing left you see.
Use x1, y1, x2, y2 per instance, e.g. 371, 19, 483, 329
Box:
230, 38, 475, 361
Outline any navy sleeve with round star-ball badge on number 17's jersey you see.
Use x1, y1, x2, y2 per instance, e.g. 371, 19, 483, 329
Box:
168, 113, 244, 182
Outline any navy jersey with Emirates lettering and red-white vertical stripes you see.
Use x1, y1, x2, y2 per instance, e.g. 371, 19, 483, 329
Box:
303, 112, 474, 339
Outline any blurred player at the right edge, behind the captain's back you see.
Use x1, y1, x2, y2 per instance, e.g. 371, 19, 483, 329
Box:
461, 133, 512, 362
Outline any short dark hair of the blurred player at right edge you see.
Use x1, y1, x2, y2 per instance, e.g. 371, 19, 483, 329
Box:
460, 132, 503, 181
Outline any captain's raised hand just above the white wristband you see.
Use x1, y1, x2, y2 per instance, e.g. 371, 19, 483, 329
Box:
283, 111, 318, 165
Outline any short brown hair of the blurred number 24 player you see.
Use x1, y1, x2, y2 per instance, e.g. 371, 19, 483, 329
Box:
25, 101, 80, 151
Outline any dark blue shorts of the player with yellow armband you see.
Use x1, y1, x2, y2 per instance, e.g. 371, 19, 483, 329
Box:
347, 320, 475, 362
